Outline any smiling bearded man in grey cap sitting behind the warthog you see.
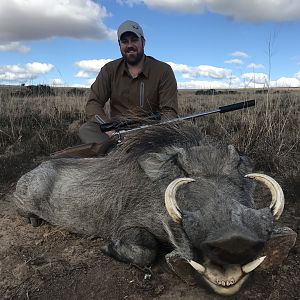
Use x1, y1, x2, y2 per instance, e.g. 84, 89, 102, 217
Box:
79, 21, 178, 149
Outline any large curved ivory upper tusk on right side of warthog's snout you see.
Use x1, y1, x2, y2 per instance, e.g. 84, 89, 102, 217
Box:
245, 173, 284, 220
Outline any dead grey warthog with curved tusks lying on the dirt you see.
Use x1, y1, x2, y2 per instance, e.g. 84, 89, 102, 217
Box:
14, 125, 284, 295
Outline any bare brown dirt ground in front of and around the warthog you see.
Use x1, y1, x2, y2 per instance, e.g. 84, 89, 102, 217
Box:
0, 176, 300, 300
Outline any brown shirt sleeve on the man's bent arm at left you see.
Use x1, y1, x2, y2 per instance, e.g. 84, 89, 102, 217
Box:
85, 66, 111, 123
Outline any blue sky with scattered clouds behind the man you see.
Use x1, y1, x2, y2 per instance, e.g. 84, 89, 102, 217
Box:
0, 0, 300, 89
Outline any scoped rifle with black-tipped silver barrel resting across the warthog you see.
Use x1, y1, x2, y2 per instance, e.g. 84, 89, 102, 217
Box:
50, 100, 255, 158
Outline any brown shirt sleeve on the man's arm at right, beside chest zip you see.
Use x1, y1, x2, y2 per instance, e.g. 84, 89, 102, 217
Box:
159, 65, 178, 121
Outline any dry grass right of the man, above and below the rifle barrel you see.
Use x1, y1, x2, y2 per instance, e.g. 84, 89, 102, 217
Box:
182, 92, 300, 177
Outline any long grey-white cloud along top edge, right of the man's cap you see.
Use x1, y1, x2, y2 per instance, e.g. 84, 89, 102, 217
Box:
118, 0, 300, 22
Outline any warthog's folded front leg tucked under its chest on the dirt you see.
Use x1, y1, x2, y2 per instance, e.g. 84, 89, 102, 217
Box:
101, 228, 158, 267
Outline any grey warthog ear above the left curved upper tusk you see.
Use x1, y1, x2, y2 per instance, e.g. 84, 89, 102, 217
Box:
138, 148, 184, 181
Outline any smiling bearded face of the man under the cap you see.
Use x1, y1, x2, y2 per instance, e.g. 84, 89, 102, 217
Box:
119, 32, 145, 65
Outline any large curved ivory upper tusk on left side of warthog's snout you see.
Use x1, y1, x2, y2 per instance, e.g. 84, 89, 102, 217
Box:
165, 178, 195, 223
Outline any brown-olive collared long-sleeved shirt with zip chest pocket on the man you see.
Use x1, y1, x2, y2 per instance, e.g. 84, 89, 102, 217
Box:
86, 56, 178, 123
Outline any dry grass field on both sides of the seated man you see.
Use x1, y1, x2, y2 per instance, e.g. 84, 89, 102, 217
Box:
0, 90, 300, 190
